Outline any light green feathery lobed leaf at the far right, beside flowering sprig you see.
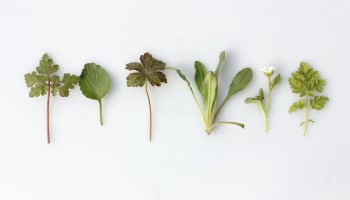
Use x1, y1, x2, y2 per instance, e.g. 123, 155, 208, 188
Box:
288, 62, 329, 135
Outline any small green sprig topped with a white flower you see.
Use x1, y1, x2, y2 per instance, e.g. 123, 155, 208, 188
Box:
245, 66, 282, 133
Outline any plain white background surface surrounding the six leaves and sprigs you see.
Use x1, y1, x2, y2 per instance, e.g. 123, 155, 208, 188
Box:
0, 0, 350, 200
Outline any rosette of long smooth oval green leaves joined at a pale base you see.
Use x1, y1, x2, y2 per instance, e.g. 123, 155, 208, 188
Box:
168, 51, 253, 134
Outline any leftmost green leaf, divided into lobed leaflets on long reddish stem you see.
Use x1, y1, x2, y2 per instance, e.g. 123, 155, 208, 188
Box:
24, 53, 79, 144
